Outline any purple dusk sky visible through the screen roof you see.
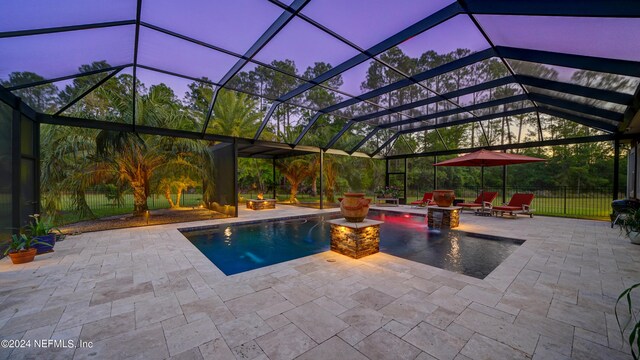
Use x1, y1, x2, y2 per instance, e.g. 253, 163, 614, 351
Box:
0, 0, 640, 106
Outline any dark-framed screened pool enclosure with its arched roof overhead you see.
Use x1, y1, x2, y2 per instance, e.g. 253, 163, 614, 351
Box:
0, 0, 640, 231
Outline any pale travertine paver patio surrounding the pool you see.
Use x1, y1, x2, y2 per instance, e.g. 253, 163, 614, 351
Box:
0, 206, 640, 360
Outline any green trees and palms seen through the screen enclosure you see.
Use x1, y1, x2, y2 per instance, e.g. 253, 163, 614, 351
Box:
1, 44, 633, 219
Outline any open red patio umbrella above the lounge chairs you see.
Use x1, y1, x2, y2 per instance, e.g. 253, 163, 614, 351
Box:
433, 149, 545, 191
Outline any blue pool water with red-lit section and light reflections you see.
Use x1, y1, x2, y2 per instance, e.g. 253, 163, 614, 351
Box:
183, 211, 524, 279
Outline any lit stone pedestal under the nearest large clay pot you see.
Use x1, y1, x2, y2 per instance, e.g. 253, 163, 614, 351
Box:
331, 224, 380, 259
